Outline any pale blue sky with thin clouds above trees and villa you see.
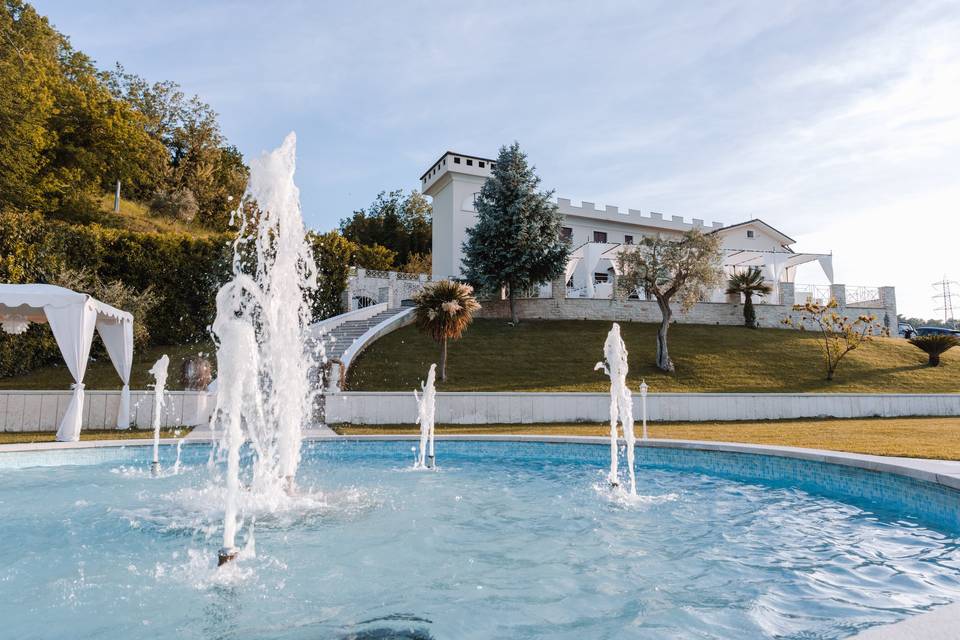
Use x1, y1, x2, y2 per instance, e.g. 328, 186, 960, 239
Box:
35, 0, 960, 317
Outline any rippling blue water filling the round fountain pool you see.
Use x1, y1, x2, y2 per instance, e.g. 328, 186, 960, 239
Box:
0, 442, 960, 640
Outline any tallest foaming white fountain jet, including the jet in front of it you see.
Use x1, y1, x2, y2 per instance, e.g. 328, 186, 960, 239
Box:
211, 133, 323, 564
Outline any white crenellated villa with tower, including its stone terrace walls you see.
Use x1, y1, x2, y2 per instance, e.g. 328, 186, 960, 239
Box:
345, 151, 897, 330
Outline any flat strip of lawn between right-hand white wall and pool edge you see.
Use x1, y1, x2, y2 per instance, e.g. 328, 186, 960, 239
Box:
334, 417, 960, 460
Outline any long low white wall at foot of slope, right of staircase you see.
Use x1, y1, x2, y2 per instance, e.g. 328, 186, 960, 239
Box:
325, 391, 960, 424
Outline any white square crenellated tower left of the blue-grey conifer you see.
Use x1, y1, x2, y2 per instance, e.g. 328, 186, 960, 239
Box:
420, 151, 495, 278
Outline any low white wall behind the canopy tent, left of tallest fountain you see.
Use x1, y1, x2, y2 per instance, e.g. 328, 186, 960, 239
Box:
0, 391, 216, 431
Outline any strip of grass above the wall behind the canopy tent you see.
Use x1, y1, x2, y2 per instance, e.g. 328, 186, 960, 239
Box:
0, 343, 215, 391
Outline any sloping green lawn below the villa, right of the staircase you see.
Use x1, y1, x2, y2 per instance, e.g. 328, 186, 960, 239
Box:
348, 319, 960, 393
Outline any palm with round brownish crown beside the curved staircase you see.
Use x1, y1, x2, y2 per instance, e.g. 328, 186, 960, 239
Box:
414, 280, 480, 381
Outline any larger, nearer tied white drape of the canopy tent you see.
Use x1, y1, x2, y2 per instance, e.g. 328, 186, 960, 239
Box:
44, 302, 97, 442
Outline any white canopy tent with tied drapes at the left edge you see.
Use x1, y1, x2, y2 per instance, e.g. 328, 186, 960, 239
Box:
0, 284, 133, 442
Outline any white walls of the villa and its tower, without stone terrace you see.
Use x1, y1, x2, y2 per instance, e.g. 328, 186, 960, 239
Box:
420, 151, 833, 302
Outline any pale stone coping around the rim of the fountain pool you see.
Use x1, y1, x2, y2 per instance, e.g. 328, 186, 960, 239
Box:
0, 429, 960, 640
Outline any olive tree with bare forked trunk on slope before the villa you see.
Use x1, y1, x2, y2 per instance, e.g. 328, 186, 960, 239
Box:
617, 229, 723, 372
